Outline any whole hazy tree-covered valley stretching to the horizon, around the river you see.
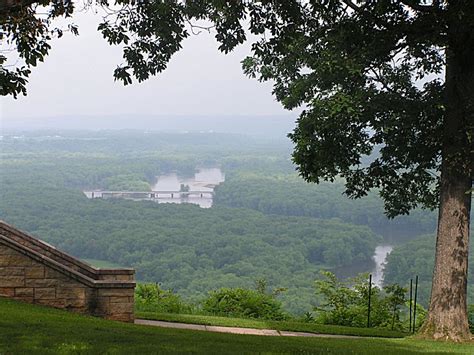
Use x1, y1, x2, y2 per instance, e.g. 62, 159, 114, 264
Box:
0, 131, 473, 314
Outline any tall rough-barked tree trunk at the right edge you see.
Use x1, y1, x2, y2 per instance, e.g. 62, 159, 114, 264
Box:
420, 9, 474, 341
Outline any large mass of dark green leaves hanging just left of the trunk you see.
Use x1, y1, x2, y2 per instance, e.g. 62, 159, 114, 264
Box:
248, 1, 452, 216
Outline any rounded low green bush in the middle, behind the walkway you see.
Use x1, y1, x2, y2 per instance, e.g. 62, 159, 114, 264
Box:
203, 288, 287, 320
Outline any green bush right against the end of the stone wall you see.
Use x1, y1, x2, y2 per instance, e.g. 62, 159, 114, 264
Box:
135, 283, 192, 313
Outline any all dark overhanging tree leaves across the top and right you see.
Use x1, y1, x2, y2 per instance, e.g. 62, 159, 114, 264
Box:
6, 0, 472, 216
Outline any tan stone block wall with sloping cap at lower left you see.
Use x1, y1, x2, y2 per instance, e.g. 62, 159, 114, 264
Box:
0, 221, 135, 322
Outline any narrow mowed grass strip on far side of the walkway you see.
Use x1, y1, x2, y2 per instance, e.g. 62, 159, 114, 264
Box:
136, 312, 410, 338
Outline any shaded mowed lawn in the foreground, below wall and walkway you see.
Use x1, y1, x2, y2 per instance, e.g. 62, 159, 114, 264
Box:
0, 298, 474, 355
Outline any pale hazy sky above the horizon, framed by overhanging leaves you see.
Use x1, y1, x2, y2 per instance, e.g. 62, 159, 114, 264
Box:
0, 5, 295, 123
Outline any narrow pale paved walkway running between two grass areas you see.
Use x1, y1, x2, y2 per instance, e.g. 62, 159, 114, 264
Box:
135, 319, 366, 339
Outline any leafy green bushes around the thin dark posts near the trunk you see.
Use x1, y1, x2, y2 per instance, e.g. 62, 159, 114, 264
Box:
315, 271, 406, 329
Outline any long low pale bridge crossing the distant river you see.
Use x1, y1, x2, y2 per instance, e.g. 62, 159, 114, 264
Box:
84, 190, 214, 200
